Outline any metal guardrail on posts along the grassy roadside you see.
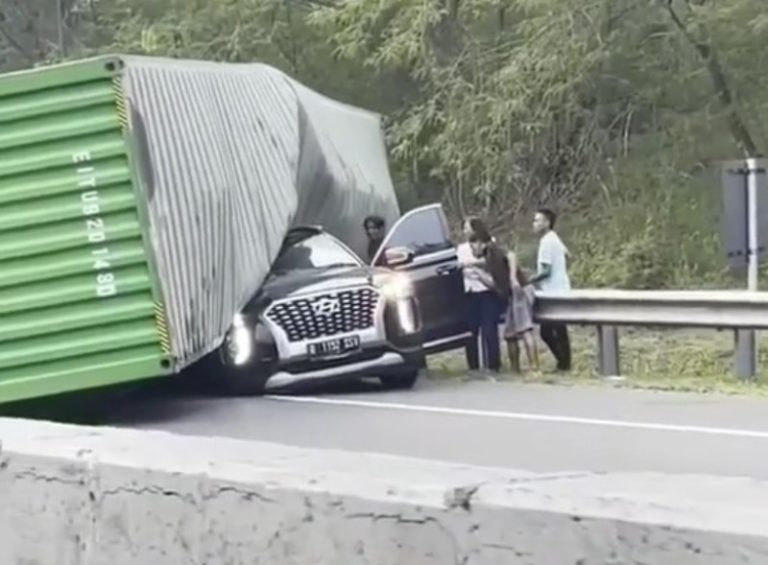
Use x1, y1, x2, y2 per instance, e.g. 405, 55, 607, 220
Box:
535, 289, 768, 379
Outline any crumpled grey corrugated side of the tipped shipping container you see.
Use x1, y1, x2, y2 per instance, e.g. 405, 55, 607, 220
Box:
123, 57, 399, 368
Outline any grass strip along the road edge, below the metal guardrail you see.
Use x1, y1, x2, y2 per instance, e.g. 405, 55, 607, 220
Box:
430, 327, 768, 397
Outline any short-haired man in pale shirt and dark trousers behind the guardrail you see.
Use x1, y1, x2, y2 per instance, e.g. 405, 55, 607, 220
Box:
530, 208, 571, 371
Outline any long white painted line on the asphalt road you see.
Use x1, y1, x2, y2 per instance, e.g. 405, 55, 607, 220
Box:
265, 395, 768, 439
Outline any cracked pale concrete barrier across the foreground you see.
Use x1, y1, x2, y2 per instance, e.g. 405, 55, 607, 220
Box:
0, 419, 768, 565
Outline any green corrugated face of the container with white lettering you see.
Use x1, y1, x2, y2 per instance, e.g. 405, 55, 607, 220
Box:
0, 59, 171, 401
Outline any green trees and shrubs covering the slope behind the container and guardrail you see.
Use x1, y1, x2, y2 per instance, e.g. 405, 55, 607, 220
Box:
0, 0, 768, 288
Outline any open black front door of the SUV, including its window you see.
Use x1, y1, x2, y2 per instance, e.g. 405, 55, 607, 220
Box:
372, 204, 470, 354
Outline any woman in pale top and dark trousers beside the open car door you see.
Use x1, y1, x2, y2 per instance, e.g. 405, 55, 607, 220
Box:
458, 217, 509, 372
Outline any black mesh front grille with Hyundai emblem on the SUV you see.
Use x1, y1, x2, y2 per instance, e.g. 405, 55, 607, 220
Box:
267, 288, 379, 342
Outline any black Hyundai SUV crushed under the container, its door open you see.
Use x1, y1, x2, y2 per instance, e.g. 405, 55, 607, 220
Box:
216, 204, 469, 394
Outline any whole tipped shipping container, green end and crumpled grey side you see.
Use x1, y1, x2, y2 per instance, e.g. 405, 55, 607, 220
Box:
0, 55, 399, 403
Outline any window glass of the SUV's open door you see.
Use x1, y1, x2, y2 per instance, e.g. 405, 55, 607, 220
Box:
374, 205, 453, 265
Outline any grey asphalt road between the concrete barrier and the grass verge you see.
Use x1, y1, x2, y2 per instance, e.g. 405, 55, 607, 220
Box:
22, 374, 768, 479
